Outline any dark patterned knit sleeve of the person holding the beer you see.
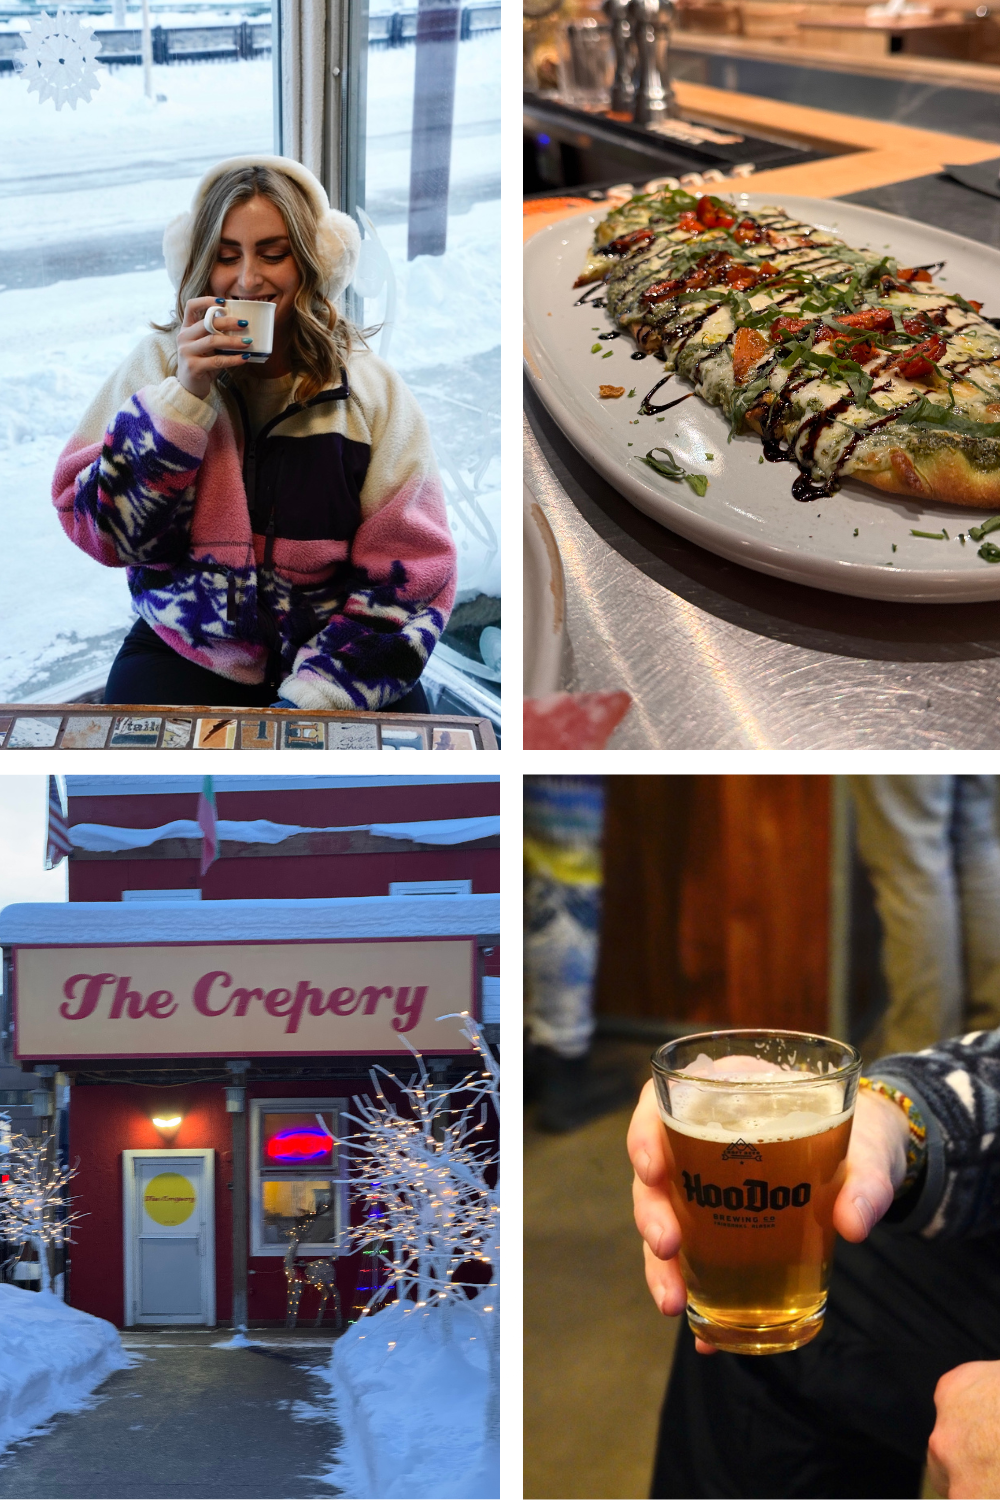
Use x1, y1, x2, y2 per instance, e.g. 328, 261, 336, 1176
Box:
870, 1031, 1000, 1239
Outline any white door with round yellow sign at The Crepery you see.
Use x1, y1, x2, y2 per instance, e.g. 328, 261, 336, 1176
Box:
124, 1151, 216, 1326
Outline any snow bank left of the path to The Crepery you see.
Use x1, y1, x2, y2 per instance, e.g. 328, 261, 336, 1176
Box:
0, 1284, 132, 1452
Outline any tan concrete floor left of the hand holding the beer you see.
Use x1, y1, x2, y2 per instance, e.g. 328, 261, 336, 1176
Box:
525, 1044, 678, 1500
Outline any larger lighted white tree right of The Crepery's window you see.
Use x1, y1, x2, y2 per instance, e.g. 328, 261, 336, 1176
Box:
332, 1013, 499, 1442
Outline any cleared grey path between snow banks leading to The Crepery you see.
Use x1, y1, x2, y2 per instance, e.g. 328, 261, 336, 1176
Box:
0, 1328, 339, 1500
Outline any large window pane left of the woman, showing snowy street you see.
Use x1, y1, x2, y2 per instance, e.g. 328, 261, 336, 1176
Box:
0, 13, 273, 702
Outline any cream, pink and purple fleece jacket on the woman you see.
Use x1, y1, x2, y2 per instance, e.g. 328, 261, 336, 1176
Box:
52, 333, 456, 710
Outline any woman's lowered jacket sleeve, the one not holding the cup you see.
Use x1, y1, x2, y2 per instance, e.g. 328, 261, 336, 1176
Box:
280, 351, 456, 710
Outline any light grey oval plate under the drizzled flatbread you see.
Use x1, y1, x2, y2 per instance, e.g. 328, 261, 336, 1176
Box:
525, 194, 1000, 603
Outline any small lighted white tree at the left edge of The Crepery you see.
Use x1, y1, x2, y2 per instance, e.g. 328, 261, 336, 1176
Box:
0, 1136, 82, 1292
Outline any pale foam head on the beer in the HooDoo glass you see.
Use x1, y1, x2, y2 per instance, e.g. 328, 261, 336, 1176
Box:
660, 1053, 847, 1142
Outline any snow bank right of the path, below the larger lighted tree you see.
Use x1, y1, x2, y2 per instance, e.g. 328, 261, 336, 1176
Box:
322, 1302, 499, 1500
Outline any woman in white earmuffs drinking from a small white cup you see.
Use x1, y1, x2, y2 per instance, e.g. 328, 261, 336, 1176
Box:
52, 156, 454, 713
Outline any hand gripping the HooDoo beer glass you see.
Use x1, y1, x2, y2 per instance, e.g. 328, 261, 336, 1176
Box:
628, 1080, 909, 1355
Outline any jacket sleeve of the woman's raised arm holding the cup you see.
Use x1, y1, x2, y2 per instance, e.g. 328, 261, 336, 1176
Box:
52, 335, 217, 567
